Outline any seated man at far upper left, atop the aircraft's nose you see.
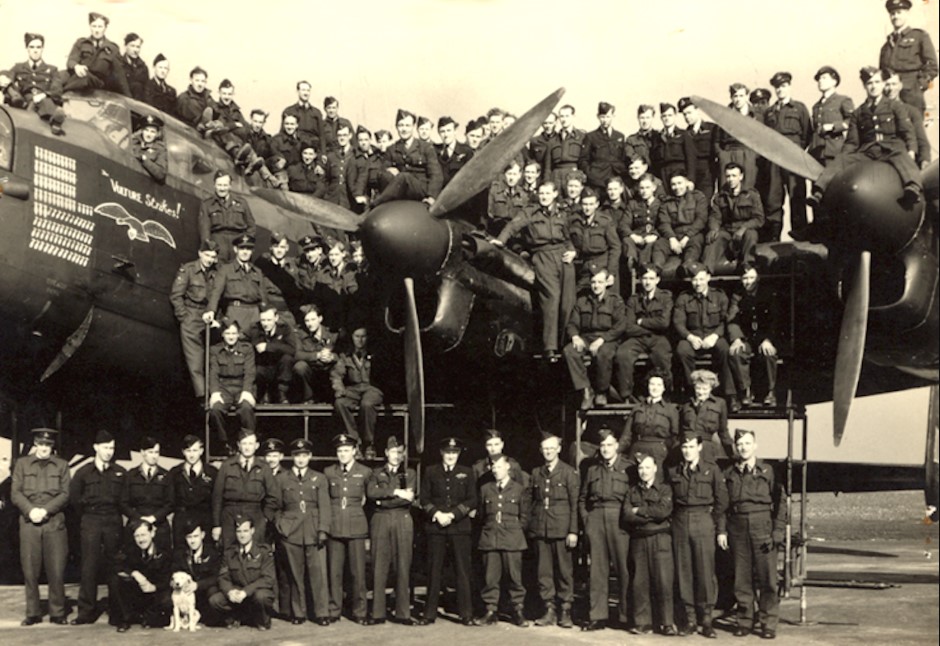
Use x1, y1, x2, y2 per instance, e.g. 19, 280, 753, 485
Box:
0, 34, 65, 135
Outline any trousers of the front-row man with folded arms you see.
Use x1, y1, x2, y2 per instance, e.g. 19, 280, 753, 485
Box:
630, 531, 674, 626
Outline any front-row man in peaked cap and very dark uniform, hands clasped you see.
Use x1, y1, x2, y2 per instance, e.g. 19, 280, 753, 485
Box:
417, 437, 477, 626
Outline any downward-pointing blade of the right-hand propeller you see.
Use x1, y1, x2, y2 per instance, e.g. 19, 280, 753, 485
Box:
832, 251, 871, 446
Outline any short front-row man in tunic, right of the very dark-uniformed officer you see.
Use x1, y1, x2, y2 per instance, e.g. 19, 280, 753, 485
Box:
474, 455, 530, 628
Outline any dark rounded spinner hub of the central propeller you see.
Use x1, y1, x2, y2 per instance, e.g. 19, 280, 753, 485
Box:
359, 201, 451, 278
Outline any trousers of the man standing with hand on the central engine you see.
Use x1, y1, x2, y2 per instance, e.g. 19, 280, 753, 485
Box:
532, 245, 576, 351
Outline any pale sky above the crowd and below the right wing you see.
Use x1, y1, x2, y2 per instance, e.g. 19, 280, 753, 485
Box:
0, 0, 940, 464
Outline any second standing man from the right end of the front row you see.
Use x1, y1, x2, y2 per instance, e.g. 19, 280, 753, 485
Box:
667, 432, 728, 639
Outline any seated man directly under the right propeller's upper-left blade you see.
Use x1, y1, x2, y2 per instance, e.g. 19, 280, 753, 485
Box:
704, 162, 764, 275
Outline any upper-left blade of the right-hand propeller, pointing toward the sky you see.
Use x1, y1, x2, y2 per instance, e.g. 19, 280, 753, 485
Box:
692, 96, 823, 182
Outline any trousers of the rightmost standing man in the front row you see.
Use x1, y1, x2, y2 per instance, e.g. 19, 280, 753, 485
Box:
728, 511, 780, 630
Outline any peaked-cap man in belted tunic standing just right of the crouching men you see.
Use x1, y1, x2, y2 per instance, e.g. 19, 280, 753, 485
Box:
274, 439, 332, 626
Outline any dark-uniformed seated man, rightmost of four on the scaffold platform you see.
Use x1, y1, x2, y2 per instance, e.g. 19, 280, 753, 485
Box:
728, 264, 780, 413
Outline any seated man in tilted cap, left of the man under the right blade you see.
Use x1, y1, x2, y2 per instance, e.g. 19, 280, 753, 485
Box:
659, 173, 708, 273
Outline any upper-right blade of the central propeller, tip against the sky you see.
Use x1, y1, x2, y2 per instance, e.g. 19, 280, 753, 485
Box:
430, 88, 565, 217
